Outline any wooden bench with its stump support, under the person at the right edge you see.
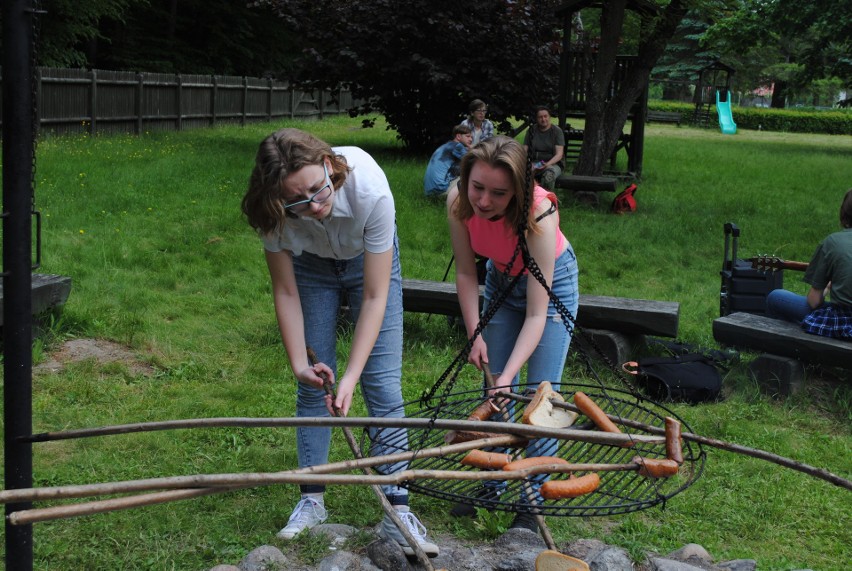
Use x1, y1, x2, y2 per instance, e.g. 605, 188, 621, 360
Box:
713, 312, 852, 395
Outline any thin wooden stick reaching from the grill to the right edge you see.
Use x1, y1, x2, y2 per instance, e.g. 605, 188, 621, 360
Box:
498, 392, 852, 490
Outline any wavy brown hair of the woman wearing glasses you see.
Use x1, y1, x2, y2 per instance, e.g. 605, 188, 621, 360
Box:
242, 128, 349, 234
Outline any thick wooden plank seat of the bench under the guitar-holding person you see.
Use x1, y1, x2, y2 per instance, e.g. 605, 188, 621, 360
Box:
713, 312, 852, 369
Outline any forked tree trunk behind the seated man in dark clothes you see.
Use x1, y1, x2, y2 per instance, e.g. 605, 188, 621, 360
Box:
574, 0, 687, 176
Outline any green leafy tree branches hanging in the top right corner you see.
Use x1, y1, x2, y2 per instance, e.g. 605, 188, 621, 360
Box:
707, 0, 852, 107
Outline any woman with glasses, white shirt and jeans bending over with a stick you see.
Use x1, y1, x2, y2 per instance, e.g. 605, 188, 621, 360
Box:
242, 129, 438, 557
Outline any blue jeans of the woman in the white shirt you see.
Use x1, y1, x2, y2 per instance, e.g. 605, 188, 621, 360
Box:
293, 237, 408, 505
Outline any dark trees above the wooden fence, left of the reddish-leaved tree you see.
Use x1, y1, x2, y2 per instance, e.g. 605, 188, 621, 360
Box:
1, 0, 298, 76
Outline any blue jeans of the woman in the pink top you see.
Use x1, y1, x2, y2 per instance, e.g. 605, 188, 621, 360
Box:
483, 247, 580, 498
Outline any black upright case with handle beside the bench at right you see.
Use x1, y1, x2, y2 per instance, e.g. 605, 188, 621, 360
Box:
719, 222, 784, 317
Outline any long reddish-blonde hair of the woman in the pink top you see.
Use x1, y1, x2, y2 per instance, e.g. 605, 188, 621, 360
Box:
451, 135, 539, 236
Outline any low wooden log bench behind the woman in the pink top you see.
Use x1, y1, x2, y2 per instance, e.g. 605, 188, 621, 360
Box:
402, 279, 680, 364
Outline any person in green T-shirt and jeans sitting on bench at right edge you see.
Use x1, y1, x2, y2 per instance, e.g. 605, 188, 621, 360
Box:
766, 188, 852, 339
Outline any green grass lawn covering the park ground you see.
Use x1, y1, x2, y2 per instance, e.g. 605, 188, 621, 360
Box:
1, 118, 852, 570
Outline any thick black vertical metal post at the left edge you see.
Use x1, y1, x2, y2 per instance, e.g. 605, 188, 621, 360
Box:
2, 0, 35, 571
